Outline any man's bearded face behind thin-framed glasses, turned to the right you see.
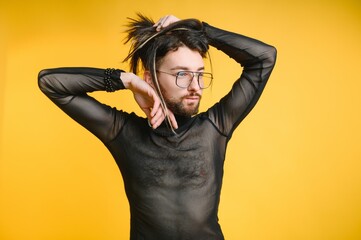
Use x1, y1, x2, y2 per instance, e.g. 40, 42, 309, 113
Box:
157, 47, 204, 116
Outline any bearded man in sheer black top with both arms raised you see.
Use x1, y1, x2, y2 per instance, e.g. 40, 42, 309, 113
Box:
39, 16, 276, 240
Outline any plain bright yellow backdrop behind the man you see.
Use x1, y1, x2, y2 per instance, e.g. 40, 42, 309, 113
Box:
0, 0, 361, 240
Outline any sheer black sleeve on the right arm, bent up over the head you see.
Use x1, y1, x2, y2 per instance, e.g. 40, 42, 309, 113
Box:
203, 23, 277, 138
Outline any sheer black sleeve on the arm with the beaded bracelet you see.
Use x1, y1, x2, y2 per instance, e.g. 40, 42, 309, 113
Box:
38, 67, 124, 142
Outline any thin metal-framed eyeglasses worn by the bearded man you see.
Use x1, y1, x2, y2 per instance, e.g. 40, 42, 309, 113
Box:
157, 70, 213, 89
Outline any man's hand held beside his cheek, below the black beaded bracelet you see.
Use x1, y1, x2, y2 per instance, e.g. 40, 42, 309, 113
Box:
121, 73, 178, 129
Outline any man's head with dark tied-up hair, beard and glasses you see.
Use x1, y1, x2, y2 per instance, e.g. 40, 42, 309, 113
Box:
126, 15, 211, 119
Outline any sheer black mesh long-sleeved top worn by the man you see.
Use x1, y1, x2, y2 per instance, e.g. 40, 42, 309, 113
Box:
39, 23, 276, 240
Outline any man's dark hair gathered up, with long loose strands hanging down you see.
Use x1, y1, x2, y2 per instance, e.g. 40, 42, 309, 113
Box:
124, 14, 209, 134
